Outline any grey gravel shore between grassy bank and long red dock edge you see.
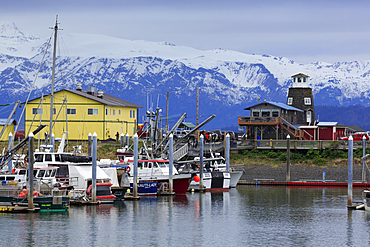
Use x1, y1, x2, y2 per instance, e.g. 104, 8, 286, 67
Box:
231, 164, 369, 182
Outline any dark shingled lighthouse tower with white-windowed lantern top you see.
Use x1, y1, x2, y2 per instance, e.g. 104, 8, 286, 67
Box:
287, 73, 316, 125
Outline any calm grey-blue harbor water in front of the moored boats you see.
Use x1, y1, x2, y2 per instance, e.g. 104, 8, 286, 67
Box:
0, 186, 370, 246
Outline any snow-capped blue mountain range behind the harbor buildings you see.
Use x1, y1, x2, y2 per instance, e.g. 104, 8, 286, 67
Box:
0, 22, 370, 127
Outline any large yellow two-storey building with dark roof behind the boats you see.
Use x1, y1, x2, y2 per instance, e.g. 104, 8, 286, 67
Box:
25, 87, 142, 140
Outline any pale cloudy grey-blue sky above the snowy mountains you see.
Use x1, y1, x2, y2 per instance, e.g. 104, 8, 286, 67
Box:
0, 0, 370, 64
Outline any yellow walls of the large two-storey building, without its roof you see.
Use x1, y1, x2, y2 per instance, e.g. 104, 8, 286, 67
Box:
25, 91, 137, 140
